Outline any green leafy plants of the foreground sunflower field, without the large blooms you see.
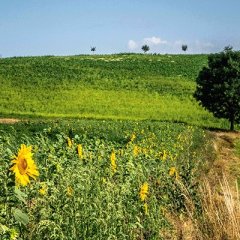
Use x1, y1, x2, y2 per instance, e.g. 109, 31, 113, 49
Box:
0, 120, 210, 240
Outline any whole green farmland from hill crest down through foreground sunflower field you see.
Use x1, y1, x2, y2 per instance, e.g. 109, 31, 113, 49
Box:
0, 54, 239, 240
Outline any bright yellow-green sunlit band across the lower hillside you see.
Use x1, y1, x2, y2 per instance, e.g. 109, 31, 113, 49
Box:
0, 84, 229, 127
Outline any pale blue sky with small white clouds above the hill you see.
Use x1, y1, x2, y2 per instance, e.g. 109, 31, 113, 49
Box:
0, 0, 240, 57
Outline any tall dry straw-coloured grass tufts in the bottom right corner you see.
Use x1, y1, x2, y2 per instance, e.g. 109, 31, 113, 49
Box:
169, 176, 240, 240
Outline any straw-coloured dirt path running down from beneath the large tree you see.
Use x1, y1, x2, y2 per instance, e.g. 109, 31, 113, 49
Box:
195, 132, 240, 240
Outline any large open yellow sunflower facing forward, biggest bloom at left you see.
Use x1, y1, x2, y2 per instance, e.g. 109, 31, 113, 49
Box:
10, 144, 39, 186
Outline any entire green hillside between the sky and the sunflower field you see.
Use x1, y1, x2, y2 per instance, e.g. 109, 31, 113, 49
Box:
0, 54, 227, 127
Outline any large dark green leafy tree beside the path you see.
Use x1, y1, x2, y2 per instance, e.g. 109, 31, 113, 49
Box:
194, 47, 240, 130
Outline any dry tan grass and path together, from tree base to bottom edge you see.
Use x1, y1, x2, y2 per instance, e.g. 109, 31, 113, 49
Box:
169, 133, 240, 240
